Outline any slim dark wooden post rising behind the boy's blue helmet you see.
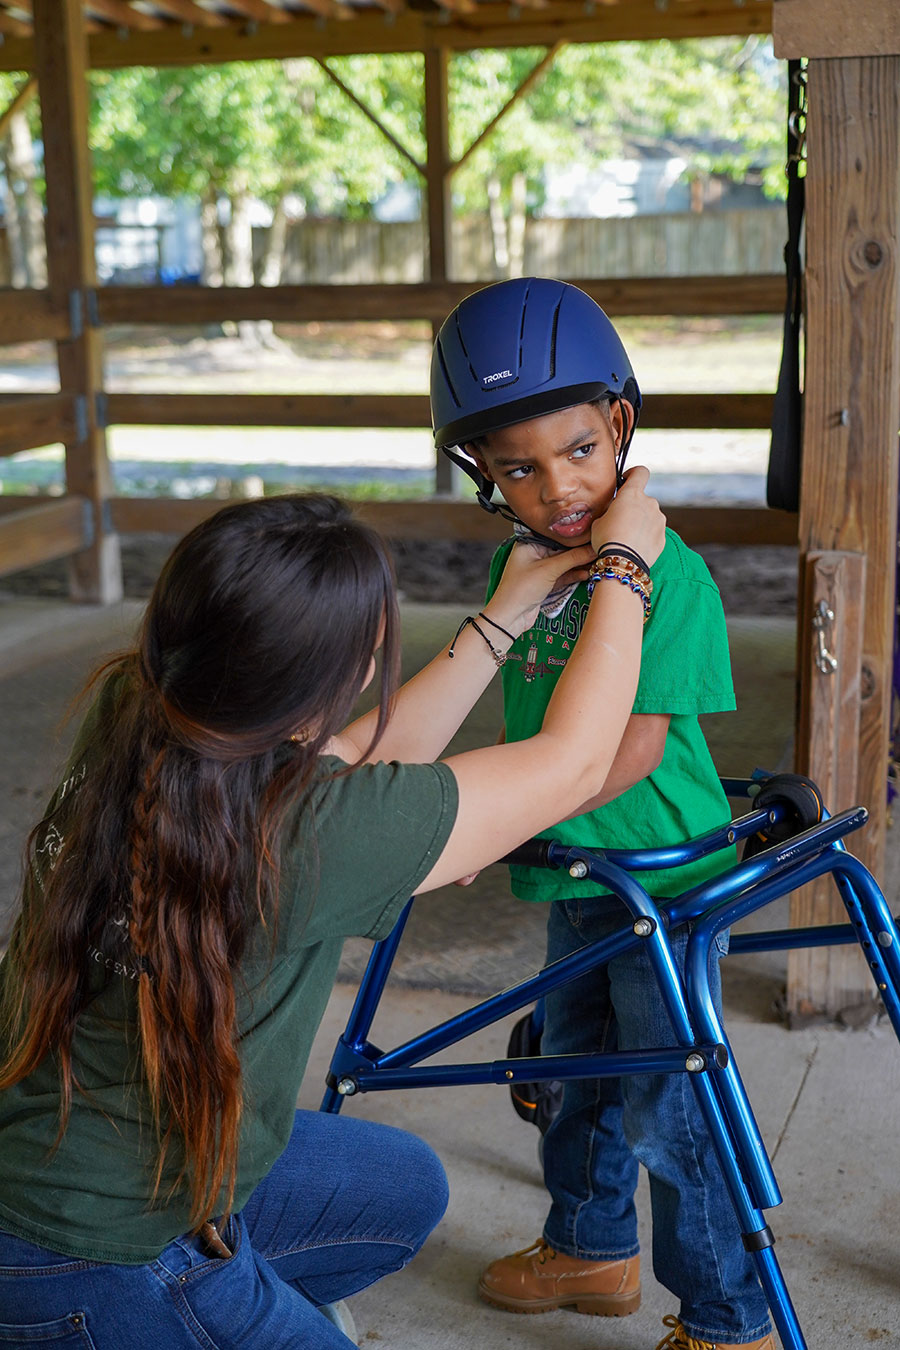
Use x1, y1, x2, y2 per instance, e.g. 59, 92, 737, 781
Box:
425, 47, 453, 493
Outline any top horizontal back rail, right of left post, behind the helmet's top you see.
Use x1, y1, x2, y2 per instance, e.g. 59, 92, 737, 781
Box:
96, 274, 785, 324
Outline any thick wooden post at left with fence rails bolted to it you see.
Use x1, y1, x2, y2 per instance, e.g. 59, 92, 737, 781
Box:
34, 0, 121, 603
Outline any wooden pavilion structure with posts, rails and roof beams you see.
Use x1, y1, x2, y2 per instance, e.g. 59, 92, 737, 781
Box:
0, 0, 900, 1014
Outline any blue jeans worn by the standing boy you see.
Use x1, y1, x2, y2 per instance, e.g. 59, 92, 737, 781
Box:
541, 896, 769, 1343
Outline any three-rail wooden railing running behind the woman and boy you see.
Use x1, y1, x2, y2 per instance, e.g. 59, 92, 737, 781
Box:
0, 275, 796, 575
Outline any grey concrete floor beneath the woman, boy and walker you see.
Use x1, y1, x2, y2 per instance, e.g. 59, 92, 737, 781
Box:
0, 593, 900, 1350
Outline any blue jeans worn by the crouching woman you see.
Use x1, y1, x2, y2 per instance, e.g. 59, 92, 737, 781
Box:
0, 1111, 448, 1350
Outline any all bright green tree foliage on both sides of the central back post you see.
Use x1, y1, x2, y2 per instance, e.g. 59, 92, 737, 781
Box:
84, 38, 784, 274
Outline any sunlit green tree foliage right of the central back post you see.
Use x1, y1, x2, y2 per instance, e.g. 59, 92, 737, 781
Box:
451, 38, 785, 211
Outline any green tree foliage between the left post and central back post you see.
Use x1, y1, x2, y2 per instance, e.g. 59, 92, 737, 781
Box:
90, 55, 424, 215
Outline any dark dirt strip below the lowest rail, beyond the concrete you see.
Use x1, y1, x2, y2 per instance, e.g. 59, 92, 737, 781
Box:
0, 535, 797, 617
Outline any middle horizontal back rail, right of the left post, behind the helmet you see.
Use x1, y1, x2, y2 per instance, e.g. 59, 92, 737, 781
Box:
104, 393, 773, 431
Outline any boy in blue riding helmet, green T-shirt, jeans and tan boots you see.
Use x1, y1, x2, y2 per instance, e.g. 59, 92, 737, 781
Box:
432, 277, 775, 1350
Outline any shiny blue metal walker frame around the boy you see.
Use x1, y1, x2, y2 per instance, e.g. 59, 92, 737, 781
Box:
321, 774, 900, 1350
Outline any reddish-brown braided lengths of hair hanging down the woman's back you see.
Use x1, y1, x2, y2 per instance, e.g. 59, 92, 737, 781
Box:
128, 745, 242, 1224
